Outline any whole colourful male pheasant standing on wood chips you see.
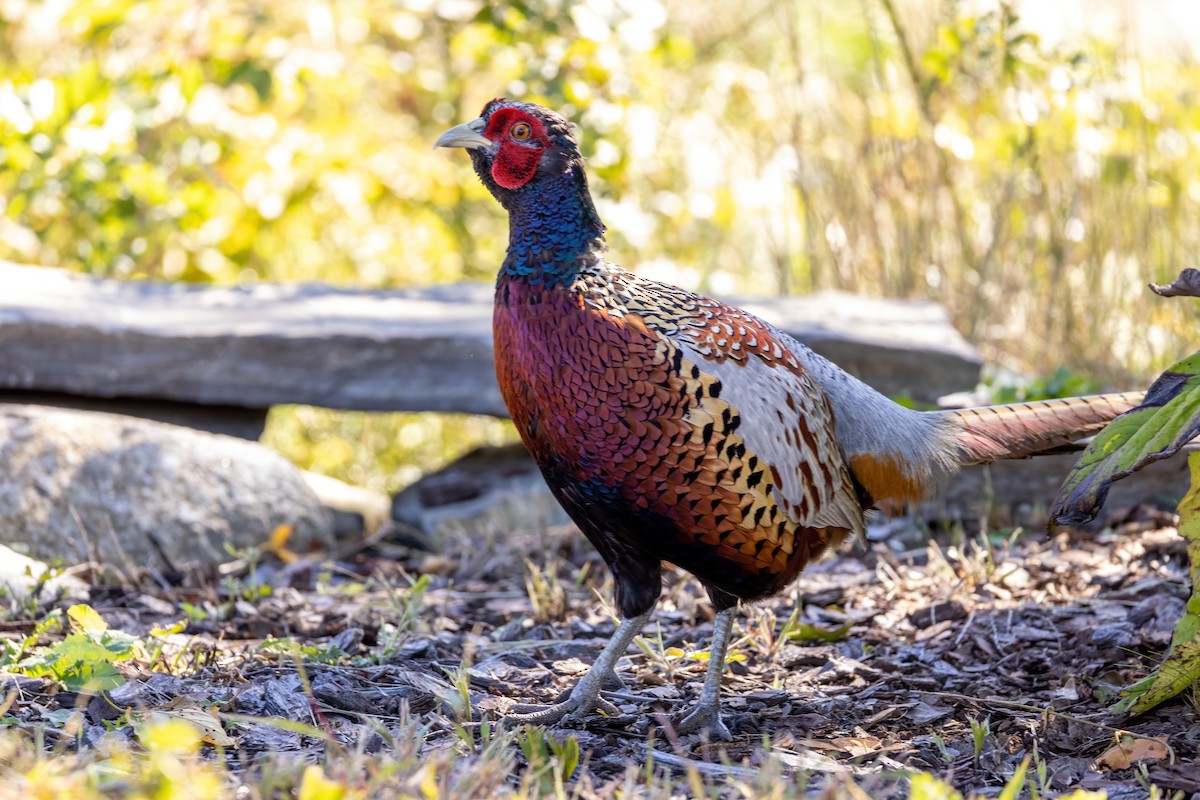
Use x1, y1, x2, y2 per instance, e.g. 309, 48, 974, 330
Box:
434, 100, 1141, 740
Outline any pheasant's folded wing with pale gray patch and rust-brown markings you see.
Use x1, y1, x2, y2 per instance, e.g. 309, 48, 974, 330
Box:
608, 269, 865, 546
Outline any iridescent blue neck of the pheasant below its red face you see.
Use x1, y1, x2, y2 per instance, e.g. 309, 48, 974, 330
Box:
500, 164, 605, 285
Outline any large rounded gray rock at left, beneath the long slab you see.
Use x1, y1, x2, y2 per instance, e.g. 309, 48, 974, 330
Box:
0, 404, 332, 569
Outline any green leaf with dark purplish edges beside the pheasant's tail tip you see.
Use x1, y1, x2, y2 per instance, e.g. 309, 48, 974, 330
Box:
1050, 353, 1200, 524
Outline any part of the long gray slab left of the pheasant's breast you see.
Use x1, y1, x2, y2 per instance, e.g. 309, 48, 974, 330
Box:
0, 263, 504, 414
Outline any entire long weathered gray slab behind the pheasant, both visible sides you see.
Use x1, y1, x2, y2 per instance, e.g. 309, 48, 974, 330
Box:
0, 261, 980, 427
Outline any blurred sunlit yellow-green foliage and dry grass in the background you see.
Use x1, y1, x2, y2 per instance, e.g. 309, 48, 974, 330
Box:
0, 0, 1200, 491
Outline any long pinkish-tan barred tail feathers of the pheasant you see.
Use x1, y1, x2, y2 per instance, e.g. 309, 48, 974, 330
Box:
938, 392, 1145, 465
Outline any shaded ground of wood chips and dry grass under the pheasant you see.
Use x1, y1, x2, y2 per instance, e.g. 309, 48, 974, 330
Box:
0, 509, 1200, 799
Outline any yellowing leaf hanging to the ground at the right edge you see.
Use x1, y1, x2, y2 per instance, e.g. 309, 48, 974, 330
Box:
1112, 453, 1200, 715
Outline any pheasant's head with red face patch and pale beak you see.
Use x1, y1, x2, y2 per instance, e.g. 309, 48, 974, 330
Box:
434, 100, 583, 206
